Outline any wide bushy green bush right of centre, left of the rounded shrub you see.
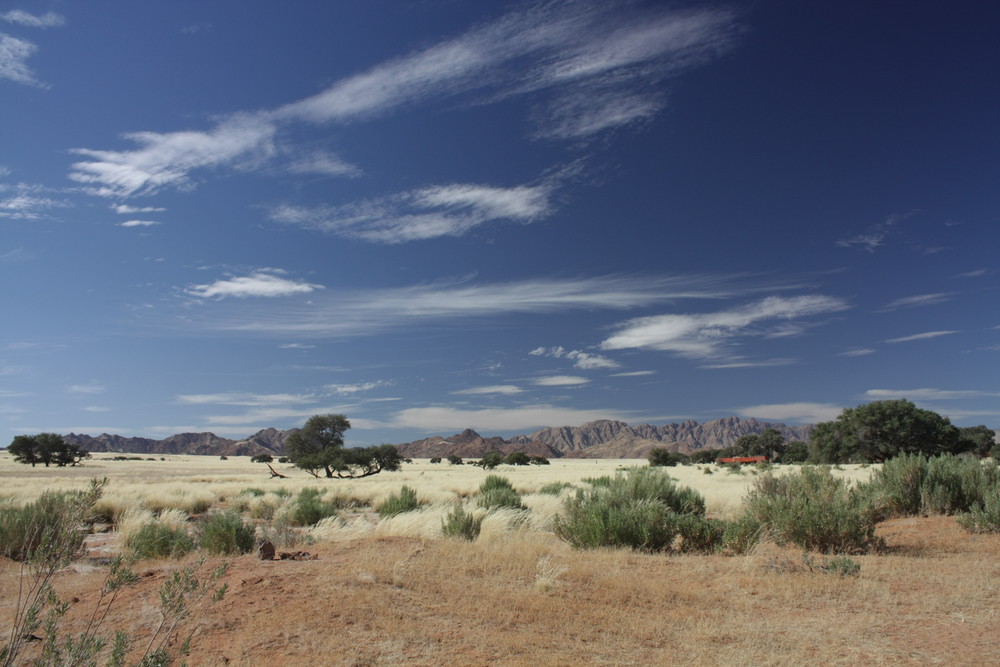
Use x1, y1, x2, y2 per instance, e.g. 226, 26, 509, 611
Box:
554, 468, 723, 551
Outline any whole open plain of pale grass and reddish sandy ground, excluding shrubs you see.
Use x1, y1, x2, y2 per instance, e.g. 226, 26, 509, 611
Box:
0, 454, 1000, 665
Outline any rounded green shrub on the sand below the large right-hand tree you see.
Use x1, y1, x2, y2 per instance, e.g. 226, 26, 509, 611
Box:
744, 466, 881, 553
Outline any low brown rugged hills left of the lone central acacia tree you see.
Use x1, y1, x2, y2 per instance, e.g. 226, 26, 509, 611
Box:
63, 428, 297, 456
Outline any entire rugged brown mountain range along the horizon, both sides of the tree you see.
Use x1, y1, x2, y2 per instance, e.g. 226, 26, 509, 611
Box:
63, 417, 812, 458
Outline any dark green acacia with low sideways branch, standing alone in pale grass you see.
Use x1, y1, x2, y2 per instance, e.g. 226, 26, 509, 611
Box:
285, 415, 403, 478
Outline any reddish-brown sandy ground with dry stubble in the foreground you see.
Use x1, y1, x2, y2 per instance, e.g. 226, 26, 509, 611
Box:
0, 517, 1000, 667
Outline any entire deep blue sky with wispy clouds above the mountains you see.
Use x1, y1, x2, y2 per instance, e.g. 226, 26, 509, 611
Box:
0, 0, 1000, 444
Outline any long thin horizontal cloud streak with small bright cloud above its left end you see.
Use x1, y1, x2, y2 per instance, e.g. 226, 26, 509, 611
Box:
168, 274, 774, 337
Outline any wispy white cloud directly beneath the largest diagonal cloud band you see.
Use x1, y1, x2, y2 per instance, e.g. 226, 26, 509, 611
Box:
270, 184, 552, 243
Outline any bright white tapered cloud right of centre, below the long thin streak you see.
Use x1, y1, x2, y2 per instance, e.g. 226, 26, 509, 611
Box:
601, 295, 850, 361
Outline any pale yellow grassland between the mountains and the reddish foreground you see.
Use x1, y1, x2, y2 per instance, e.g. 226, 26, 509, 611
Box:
0, 454, 871, 541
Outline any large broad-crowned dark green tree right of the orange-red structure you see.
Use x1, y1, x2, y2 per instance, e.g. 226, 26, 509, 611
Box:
809, 399, 959, 463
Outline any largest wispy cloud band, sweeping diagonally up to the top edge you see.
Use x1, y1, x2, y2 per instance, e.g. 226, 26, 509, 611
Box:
70, 1, 740, 197
